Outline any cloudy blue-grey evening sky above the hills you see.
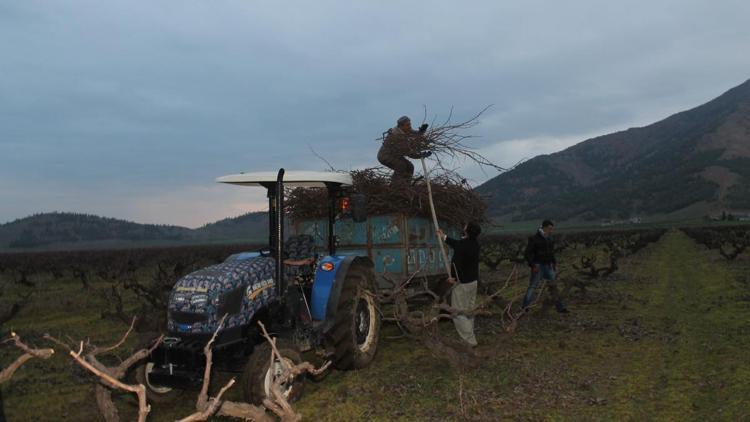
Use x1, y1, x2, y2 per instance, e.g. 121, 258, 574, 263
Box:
0, 0, 750, 227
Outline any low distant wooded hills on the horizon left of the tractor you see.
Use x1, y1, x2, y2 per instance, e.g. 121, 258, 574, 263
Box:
0, 212, 268, 250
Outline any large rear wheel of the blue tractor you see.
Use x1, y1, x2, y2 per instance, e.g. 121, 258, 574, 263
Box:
329, 264, 380, 369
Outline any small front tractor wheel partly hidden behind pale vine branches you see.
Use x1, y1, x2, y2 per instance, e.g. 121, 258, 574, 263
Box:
247, 339, 304, 405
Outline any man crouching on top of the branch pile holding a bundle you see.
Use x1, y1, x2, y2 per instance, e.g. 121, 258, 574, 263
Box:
378, 116, 430, 184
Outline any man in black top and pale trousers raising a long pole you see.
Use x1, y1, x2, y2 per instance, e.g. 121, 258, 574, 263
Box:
438, 222, 482, 347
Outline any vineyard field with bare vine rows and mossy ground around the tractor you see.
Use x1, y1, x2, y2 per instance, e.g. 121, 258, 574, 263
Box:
0, 230, 750, 421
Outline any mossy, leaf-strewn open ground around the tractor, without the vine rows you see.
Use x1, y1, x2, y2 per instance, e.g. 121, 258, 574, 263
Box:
0, 231, 750, 421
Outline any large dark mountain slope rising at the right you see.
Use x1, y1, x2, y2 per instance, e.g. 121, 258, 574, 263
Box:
476, 80, 750, 221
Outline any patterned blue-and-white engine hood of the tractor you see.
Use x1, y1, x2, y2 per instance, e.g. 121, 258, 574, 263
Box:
167, 256, 276, 334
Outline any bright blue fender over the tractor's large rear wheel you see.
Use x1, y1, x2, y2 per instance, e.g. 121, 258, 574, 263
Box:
310, 255, 374, 324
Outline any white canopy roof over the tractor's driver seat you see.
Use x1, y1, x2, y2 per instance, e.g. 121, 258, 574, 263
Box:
216, 171, 352, 188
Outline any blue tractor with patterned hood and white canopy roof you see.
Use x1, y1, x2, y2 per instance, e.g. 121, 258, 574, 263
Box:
136, 169, 381, 404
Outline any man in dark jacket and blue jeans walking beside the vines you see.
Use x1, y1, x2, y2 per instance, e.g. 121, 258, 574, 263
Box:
522, 220, 568, 313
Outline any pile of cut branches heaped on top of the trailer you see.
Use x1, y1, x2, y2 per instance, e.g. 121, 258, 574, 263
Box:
286, 167, 487, 226
